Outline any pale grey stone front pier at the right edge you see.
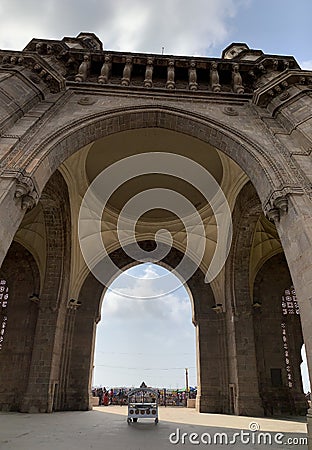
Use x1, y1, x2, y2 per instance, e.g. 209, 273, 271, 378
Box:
275, 194, 312, 450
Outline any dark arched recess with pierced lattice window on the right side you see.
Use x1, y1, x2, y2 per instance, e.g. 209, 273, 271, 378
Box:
253, 253, 308, 415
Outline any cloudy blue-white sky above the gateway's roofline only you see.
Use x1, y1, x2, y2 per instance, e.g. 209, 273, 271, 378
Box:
0, 0, 312, 68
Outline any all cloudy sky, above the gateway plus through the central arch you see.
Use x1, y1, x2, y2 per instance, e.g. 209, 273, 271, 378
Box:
0, 0, 312, 388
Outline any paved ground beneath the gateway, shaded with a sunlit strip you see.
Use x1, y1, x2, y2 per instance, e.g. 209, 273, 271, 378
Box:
0, 406, 307, 450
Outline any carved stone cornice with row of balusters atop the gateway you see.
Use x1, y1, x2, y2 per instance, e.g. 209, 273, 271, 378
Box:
0, 33, 300, 96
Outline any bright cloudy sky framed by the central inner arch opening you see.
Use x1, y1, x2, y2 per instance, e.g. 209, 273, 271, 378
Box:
92, 263, 196, 398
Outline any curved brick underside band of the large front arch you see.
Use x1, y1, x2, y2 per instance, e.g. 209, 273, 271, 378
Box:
22, 106, 289, 201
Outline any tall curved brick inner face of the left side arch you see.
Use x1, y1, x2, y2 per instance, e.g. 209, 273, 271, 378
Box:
20, 171, 70, 412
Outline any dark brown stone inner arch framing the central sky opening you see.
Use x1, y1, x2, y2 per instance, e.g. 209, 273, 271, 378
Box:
59, 241, 228, 413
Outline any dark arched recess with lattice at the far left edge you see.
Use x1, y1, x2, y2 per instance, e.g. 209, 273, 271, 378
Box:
0, 242, 40, 411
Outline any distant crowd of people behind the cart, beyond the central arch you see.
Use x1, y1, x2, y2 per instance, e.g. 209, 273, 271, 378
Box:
92, 387, 197, 406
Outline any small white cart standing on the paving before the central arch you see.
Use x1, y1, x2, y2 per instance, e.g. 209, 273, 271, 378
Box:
127, 388, 158, 424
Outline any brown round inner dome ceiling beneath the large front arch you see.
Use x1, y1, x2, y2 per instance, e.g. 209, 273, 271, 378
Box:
86, 128, 223, 220
